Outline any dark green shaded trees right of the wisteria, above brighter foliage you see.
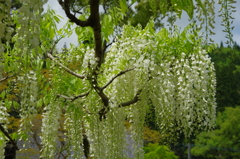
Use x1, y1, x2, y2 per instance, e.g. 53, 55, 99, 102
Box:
209, 45, 240, 111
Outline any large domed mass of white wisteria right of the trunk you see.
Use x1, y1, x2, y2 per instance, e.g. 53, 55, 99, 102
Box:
100, 22, 216, 154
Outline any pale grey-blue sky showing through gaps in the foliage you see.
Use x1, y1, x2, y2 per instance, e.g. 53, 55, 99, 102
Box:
44, 0, 240, 49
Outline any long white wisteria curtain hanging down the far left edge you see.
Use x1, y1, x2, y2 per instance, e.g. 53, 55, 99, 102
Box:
0, 0, 46, 157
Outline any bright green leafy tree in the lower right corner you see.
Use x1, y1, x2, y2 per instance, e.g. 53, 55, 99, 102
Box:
192, 107, 240, 159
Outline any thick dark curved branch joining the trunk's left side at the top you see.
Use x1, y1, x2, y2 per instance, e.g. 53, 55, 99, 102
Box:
58, 0, 90, 27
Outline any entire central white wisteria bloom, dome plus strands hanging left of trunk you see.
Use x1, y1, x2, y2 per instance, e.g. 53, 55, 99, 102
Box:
39, 21, 216, 159
